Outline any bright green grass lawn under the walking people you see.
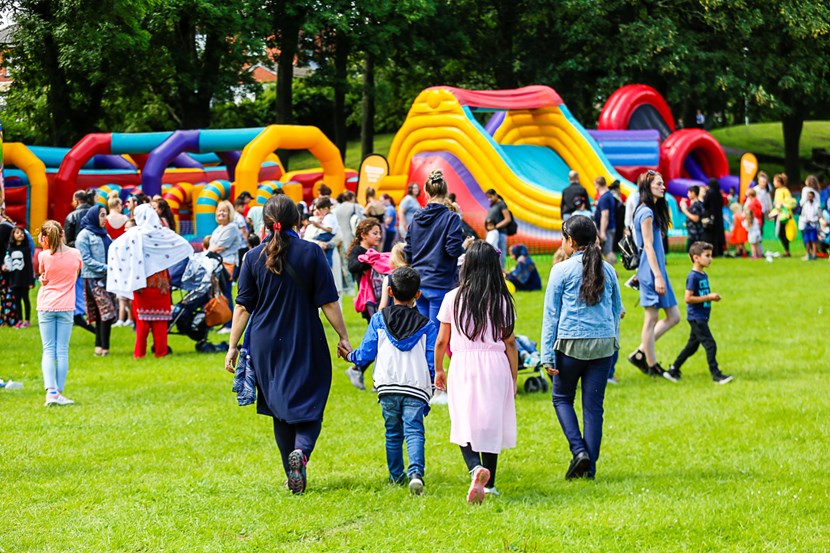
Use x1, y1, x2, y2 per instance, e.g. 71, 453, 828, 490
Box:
0, 247, 830, 553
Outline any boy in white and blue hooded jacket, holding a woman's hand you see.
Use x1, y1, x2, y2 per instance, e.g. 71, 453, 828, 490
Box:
346, 267, 438, 495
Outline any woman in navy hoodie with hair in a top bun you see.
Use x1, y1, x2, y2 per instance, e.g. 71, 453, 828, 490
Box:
404, 169, 464, 324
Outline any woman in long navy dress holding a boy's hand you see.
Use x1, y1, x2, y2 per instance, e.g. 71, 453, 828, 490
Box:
225, 196, 351, 494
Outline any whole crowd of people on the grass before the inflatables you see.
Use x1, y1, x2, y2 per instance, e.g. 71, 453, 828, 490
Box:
0, 164, 830, 503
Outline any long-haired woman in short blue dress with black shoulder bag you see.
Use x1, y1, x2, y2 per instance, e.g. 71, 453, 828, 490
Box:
628, 170, 680, 376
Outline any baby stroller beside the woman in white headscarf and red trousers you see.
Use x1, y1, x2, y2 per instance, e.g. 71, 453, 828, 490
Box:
167, 252, 228, 353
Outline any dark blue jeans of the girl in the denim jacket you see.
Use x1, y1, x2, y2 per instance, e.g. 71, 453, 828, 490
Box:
553, 351, 613, 476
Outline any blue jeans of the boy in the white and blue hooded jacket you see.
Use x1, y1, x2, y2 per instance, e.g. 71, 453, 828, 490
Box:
379, 395, 427, 482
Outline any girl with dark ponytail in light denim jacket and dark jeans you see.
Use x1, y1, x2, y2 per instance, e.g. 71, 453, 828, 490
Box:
542, 215, 623, 480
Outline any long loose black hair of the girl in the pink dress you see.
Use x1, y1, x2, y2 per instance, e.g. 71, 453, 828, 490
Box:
453, 240, 516, 341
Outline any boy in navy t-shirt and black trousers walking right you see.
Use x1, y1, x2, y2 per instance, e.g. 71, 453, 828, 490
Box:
663, 242, 732, 384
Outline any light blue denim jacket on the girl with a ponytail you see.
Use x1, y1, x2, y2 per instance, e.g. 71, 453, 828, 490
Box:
542, 252, 623, 364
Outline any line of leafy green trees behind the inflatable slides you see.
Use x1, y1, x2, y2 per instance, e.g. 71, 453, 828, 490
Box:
0, 0, 830, 179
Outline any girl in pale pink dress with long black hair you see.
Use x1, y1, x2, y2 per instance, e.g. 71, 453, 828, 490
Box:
435, 240, 519, 503
